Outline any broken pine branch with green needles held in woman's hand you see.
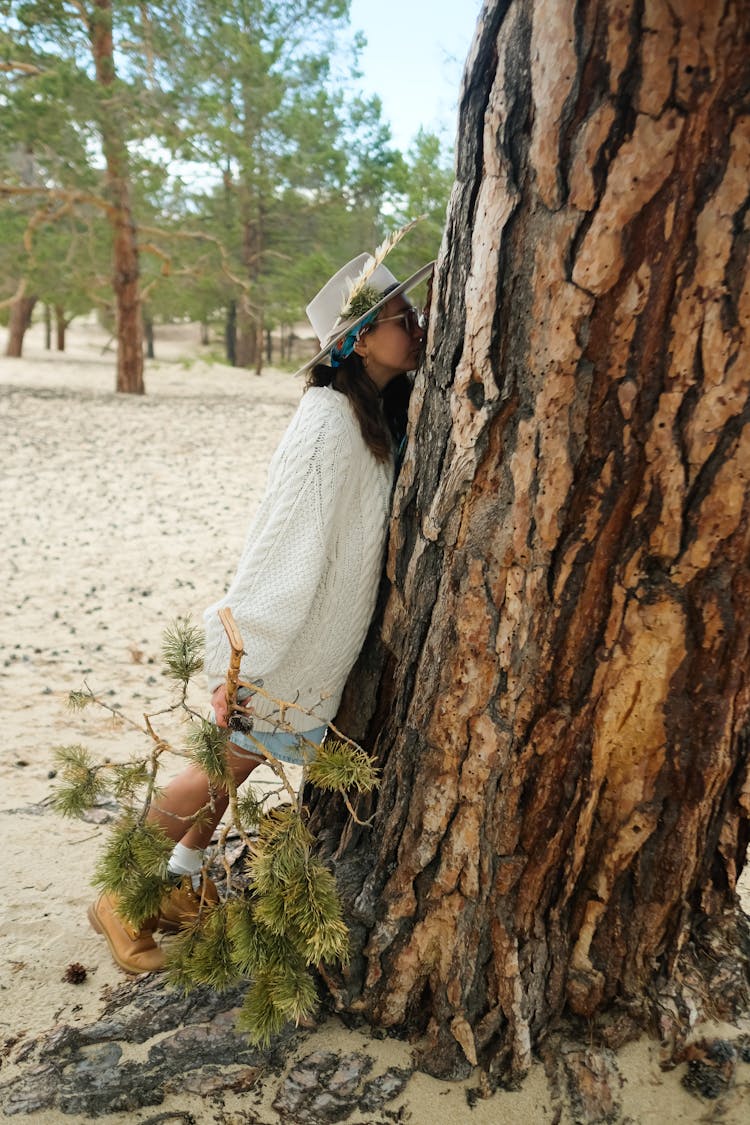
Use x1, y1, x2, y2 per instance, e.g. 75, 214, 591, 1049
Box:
55, 610, 378, 1044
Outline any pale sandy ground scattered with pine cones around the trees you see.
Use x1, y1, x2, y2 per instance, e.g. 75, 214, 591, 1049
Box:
0, 325, 750, 1125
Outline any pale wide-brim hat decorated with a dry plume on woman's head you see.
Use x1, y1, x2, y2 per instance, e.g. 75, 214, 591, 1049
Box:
295, 253, 435, 375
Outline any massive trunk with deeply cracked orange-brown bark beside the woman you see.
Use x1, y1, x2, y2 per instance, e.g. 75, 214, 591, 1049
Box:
305, 0, 750, 1078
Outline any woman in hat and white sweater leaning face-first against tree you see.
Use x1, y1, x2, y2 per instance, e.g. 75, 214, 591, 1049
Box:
89, 243, 433, 973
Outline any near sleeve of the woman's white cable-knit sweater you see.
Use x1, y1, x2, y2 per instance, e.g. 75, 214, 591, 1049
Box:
204, 400, 352, 691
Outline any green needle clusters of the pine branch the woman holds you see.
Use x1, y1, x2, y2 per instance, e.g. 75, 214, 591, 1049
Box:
55, 621, 377, 1043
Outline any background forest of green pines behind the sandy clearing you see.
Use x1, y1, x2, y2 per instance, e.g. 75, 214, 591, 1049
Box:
0, 0, 453, 378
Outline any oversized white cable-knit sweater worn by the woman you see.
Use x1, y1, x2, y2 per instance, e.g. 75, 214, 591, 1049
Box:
204, 387, 394, 731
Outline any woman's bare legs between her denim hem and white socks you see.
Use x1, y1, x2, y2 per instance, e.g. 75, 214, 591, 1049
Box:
147, 746, 262, 848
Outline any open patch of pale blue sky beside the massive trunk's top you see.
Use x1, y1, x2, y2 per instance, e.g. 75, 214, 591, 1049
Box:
351, 0, 481, 150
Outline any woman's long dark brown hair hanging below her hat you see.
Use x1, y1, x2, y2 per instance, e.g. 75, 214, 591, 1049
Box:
305, 352, 412, 461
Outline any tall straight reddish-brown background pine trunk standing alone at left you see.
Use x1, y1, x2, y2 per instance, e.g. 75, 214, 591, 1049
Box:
89, 0, 145, 395
